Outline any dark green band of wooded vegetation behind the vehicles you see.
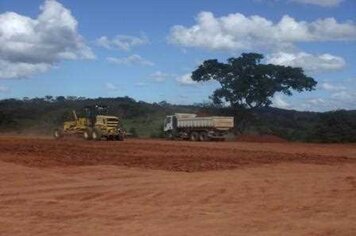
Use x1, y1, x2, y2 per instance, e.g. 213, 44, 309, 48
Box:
0, 96, 356, 142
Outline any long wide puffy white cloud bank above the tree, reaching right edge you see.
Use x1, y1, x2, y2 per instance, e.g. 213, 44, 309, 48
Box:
169, 12, 356, 51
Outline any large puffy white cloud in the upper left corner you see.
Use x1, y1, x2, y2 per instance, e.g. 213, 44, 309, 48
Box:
0, 0, 95, 79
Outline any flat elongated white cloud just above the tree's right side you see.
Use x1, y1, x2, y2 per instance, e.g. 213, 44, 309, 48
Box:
267, 52, 346, 73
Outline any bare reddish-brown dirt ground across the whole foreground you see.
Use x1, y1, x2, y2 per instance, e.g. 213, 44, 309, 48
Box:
0, 137, 356, 236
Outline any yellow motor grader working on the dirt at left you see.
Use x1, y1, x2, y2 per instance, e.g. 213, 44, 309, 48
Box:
53, 105, 125, 141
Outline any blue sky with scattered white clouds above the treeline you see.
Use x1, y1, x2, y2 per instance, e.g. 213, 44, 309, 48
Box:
0, 0, 356, 111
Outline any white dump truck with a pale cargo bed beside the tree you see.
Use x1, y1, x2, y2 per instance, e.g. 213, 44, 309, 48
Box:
163, 113, 234, 141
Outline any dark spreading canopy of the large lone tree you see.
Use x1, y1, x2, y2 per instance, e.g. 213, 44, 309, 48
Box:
192, 53, 317, 109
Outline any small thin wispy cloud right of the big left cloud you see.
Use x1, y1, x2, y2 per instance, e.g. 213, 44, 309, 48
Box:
97, 35, 149, 51
